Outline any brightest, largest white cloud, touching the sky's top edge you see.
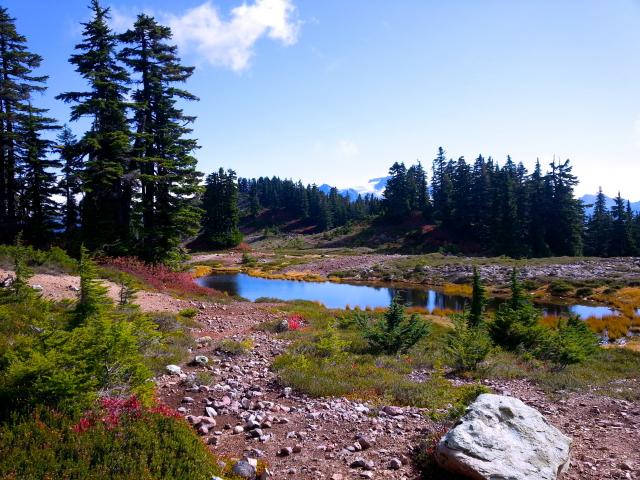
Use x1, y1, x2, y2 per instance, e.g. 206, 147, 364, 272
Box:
168, 0, 300, 72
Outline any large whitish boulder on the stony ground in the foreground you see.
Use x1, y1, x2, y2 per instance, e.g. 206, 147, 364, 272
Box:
436, 394, 571, 480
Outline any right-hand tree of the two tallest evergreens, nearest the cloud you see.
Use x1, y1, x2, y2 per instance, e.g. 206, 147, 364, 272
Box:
119, 15, 201, 262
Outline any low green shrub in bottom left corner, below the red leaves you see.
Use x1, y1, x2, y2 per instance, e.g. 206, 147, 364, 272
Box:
0, 409, 224, 480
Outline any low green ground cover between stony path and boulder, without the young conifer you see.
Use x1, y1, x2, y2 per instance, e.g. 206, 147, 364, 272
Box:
273, 302, 486, 417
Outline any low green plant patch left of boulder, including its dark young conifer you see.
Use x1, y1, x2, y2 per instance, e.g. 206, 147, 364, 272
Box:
273, 302, 484, 417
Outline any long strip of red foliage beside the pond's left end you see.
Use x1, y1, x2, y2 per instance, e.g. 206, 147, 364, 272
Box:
100, 257, 219, 295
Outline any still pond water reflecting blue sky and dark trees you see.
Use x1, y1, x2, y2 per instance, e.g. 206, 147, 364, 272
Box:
197, 273, 617, 318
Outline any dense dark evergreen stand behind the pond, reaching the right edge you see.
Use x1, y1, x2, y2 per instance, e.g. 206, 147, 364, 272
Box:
382, 148, 640, 257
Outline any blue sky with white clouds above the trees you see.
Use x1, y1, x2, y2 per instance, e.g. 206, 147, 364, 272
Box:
2, 0, 640, 200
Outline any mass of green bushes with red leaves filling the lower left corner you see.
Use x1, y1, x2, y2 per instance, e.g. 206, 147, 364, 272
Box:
0, 245, 221, 480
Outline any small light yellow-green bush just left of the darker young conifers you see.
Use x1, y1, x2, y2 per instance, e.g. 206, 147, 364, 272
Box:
446, 315, 492, 372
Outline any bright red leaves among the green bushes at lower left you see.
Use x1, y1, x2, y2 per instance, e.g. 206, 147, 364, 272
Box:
72, 395, 180, 433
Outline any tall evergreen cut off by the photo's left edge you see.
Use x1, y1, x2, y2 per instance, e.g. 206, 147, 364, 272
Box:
0, 7, 47, 243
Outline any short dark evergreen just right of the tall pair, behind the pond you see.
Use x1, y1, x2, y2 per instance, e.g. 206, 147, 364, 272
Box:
201, 168, 242, 248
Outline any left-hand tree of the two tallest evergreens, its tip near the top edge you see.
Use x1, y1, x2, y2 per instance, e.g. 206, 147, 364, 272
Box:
57, 0, 135, 252
